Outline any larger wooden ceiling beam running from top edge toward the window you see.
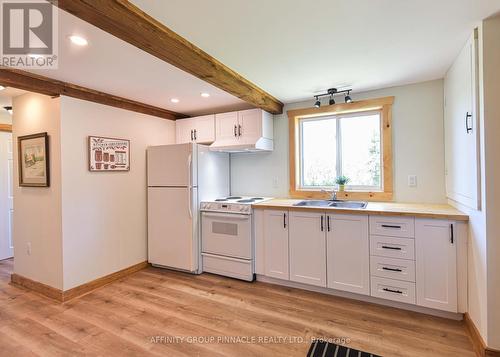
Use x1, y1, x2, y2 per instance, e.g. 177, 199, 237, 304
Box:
47, 0, 283, 114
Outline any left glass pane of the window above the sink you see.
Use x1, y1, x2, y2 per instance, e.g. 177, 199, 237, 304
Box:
301, 118, 337, 187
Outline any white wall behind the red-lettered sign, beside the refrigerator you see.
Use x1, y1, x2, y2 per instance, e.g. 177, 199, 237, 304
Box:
61, 97, 175, 290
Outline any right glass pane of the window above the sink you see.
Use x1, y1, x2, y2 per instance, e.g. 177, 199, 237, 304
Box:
340, 114, 381, 187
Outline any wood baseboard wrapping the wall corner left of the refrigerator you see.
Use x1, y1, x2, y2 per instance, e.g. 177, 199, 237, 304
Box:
10, 261, 149, 302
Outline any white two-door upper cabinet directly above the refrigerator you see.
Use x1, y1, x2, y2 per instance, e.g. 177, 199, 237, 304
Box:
175, 114, 215, 144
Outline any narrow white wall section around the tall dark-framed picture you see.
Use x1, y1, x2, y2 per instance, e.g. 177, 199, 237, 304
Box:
12, 93, 63, 289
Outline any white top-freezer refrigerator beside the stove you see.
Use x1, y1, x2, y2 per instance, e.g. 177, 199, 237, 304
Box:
147, 143, 230, 274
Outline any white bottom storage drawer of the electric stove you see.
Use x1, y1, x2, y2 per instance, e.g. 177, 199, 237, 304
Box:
201, 253, 254, 281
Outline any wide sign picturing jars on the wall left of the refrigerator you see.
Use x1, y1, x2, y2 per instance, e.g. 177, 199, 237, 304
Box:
89, 136, 130, 172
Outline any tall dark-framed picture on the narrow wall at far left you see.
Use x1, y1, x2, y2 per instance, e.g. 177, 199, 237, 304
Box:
17, 133, 50, 187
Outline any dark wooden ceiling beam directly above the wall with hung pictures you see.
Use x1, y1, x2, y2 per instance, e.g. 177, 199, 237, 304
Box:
0, 67, 187, 120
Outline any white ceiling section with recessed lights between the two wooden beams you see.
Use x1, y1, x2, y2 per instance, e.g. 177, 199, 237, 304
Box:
28, 10, 250, 115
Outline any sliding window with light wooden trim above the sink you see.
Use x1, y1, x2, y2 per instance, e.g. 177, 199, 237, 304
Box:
288, 97, 393, 200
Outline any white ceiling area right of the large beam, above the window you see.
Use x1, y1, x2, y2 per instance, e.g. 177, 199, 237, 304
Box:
132, 0, 500, 102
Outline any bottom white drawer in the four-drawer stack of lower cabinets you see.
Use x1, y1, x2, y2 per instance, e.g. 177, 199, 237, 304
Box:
371, 276, 415, 304
